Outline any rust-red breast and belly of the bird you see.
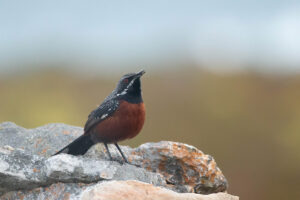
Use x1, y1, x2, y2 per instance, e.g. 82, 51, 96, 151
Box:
90, 101, 145, 143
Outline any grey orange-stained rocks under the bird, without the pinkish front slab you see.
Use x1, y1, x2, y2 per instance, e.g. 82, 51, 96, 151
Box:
0, 122, 237, 199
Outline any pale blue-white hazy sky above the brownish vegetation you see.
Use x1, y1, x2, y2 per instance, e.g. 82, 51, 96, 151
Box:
0, 0, 300, 73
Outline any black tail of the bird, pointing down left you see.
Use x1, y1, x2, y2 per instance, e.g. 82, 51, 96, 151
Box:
54, 135, 94, 155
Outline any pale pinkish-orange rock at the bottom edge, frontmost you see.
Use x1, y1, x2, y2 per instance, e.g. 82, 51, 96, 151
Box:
81, 181, 239, 200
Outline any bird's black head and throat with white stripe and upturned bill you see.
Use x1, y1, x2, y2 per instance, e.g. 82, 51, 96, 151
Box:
116, 70, 145, 103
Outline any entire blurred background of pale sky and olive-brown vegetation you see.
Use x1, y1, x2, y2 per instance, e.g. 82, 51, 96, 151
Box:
0, 0, 300, 200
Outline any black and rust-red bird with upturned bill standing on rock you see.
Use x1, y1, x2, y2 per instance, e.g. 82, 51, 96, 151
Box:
53, 70, 146, 163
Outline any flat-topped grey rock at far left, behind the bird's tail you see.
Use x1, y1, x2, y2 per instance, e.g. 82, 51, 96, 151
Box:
0, 122, 83, 157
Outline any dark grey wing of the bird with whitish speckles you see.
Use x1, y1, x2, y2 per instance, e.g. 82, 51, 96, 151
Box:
84, 99, 119, 134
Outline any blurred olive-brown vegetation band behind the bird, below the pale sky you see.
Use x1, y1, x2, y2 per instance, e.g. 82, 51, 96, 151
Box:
0, 68, 300, 200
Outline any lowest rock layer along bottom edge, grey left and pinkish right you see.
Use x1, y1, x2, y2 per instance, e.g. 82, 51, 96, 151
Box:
0, 180, 239, 200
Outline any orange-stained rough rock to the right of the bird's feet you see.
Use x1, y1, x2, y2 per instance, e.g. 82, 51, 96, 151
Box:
87, 141, 228, 194
